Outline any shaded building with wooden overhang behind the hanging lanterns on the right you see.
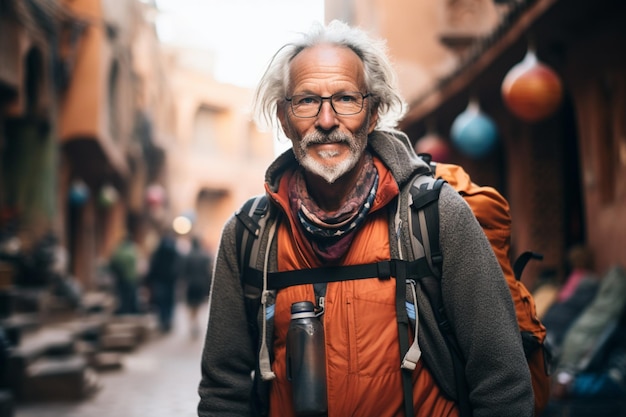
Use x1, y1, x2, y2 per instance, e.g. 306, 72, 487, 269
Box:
326, 0, 626, 286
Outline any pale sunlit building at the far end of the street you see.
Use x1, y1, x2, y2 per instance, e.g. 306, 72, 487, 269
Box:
157, 47, 274, 251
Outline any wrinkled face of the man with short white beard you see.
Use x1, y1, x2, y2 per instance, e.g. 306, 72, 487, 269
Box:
277, 45, 378, 184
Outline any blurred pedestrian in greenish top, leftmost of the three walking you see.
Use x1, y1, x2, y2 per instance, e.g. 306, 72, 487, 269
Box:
109, 233, 139, 314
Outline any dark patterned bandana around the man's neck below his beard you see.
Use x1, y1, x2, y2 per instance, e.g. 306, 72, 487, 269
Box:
289, 152, 378, 264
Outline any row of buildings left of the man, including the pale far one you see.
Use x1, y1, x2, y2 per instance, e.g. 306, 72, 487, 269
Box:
0, 0, 273, 291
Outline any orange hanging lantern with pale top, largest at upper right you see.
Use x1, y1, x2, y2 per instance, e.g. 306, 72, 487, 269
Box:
501, 49, 563, 122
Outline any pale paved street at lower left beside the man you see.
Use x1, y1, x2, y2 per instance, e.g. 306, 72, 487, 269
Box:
15, 305, 206, 417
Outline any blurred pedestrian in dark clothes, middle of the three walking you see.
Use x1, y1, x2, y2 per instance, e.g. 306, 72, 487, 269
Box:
146, 232, 181, 333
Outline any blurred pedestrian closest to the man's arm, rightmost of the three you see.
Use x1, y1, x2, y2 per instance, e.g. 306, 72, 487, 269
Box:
181, 237, 212, 338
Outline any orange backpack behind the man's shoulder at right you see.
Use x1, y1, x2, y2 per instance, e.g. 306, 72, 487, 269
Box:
432, 159, 550, 415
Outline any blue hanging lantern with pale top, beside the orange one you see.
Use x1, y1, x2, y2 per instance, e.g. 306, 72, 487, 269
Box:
450, 100, 498, 158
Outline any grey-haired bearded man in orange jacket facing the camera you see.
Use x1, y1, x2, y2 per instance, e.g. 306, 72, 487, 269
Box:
198, 22, 533, 417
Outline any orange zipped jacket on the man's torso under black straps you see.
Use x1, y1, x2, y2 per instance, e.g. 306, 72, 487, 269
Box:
270, 159, 458, 417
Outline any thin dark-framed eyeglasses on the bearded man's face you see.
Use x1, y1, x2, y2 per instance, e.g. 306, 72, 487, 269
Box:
285, 91, 370, 118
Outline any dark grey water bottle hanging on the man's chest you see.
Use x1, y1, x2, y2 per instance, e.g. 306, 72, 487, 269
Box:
286, 301, 328, 417
